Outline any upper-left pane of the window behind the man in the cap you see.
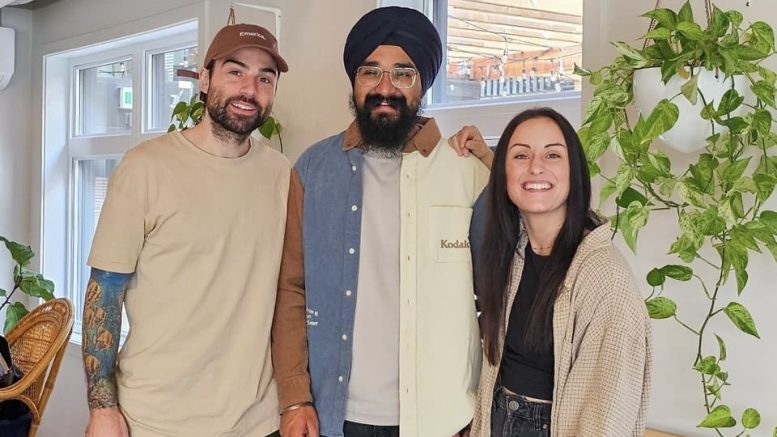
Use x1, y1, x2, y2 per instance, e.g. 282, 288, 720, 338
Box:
77, 60, 133, 135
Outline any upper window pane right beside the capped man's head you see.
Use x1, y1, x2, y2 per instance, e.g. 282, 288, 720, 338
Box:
148, 47, 199, 130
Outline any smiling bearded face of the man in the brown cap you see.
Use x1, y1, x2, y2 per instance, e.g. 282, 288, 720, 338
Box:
200, 48, 278, 137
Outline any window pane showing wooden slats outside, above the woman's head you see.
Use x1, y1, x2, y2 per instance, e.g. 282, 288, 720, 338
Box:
432, 0, 583, 103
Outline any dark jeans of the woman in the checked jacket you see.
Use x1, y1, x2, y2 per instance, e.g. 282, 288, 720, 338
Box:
491, 386, 551, 437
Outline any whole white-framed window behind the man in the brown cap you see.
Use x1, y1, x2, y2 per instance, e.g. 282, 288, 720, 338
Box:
42, 22, 199, 342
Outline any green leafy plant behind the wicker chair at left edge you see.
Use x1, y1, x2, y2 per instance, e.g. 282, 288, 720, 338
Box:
0, 236, 54, 333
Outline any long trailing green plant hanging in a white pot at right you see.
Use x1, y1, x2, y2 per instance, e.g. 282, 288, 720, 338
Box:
576, 2, 777, 436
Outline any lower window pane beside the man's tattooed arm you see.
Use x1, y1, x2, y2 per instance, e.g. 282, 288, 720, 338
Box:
73, 159, 126, 329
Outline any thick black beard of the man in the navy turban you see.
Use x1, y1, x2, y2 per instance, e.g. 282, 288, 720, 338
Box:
350, 94, 421, 157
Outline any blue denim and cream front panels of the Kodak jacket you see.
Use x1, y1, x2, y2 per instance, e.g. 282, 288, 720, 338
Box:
295, 120, 488, 437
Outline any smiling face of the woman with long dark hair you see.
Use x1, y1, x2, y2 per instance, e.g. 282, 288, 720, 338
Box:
505, 117, 569, 224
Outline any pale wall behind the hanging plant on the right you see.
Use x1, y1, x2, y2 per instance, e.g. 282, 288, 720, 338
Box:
584, 0, 777, 436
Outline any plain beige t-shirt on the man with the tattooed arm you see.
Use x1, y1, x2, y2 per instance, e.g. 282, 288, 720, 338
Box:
88, 132, 291, 437
